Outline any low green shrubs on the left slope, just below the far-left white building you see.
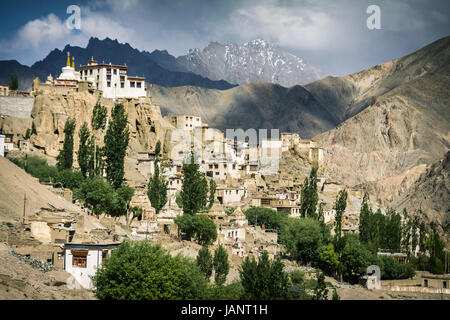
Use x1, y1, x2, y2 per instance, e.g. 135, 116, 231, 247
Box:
10, 155, 58, 183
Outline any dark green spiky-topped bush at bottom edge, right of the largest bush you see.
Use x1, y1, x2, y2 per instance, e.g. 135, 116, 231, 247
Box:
239, 251, 289, 300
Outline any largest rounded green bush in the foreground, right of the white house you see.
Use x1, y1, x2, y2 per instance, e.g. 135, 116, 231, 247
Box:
93, 241, 209, 300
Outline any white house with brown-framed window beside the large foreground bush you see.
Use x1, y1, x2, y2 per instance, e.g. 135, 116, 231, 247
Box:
64, 243, 120, 289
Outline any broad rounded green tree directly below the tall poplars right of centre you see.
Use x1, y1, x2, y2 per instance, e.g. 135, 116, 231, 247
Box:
280, 218, 323, 264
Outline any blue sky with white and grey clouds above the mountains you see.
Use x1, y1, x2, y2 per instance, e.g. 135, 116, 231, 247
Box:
0, 0, 450, 76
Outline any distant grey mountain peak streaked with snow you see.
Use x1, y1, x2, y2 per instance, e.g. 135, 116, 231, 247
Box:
178, 39, 324, 87
